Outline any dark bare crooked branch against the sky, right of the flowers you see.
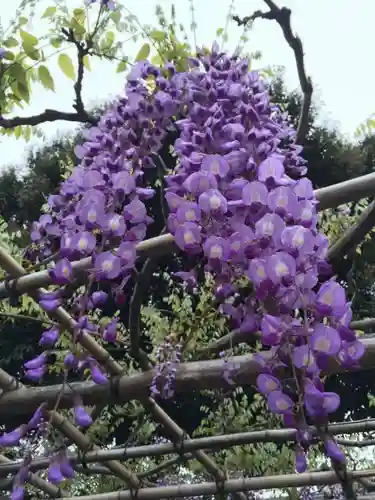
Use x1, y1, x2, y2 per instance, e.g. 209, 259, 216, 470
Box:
233, 0, 313, 144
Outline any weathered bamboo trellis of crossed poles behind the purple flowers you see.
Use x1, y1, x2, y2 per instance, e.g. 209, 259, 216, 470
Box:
0, 174, 375, 500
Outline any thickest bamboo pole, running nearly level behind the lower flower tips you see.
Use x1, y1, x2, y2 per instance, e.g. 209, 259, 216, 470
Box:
0, 337, 375, 417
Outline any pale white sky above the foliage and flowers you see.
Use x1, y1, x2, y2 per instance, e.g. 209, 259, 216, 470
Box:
0, 0, 375, 171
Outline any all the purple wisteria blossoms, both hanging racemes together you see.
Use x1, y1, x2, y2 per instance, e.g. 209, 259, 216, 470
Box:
0, 44, 364, 498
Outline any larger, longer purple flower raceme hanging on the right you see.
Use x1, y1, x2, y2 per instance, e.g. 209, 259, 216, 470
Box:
162, 45, 364, 471
